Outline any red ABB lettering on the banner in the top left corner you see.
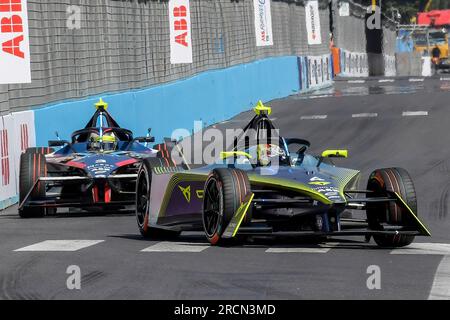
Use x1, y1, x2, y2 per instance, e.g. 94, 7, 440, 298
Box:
0, 0, 25, 59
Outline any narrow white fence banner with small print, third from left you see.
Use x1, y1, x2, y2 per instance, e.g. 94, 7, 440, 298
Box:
253, 0, 273, 47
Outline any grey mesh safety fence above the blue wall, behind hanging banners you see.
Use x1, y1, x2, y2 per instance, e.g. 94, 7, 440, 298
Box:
0, 0, 330, 114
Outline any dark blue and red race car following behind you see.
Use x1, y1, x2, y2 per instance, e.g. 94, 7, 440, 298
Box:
19, 99, 160, 218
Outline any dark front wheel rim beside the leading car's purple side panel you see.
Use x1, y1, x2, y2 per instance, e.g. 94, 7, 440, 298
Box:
203, 178, 222, 238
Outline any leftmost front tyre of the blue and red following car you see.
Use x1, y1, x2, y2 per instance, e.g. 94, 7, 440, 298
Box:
19, 152, 47, 218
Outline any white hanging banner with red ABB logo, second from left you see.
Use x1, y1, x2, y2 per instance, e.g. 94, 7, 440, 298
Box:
169, 0, 192, 64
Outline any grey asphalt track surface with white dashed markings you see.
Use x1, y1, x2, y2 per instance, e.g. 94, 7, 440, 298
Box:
0, 78, 450, 299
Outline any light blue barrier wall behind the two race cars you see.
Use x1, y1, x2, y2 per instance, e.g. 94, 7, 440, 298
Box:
35, 56, 300, 146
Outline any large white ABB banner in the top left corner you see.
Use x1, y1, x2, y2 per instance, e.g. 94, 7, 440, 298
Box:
0, 0, 31, 84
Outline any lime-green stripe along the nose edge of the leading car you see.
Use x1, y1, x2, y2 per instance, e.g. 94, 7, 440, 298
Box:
248, 174, 332, 204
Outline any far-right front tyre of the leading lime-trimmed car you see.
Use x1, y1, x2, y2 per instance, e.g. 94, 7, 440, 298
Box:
367, 168, 417, 248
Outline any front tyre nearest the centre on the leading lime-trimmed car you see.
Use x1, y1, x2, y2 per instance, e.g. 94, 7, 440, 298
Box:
202, 168, 252, 245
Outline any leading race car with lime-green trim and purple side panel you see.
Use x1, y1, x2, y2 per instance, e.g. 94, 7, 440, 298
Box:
136, 103, 430, 247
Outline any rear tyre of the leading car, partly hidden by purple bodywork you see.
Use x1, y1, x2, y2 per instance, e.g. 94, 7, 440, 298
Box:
135, 158, 181, 239
